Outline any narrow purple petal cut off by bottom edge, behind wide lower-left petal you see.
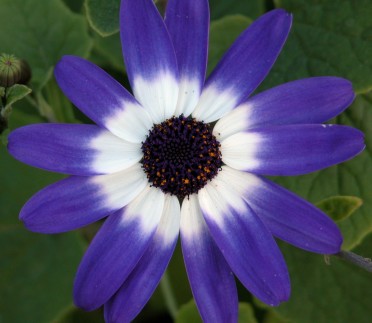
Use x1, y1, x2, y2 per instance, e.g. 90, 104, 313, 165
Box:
105, 195, 180, 322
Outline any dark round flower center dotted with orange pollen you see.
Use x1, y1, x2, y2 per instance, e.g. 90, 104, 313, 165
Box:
142, 115, 222, 198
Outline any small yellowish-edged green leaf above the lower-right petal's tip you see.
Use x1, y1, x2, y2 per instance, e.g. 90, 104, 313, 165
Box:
316, 196, 363, 221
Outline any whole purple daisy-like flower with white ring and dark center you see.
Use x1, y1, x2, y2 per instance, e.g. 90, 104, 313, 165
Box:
8, 0, 364, 322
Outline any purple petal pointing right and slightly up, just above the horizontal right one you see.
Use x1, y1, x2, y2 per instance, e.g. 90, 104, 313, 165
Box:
213, 76, 355, 140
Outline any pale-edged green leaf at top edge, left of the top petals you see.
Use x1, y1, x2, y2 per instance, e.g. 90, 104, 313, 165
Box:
84, 0, 120, 37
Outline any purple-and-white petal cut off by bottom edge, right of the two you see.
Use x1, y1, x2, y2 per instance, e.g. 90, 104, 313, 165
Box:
181, 195, 238, 323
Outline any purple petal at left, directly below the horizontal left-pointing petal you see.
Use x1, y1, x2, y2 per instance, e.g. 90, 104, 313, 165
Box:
20, 164, 147, 233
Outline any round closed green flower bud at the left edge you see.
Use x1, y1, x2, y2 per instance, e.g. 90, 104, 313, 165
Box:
0, 54, 31, 87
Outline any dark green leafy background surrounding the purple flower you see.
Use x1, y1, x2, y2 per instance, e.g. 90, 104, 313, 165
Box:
0, 0, 372, 323
